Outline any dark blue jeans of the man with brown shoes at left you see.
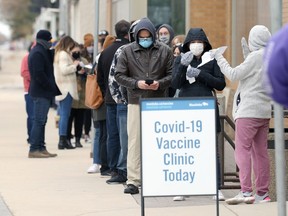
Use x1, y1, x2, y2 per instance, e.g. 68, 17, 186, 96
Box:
30, 97, 51, 152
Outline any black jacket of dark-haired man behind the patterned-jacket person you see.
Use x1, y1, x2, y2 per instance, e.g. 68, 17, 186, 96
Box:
97, 38, 129, 104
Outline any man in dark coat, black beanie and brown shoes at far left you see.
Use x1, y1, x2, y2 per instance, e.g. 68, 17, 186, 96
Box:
28, 30, 61, 158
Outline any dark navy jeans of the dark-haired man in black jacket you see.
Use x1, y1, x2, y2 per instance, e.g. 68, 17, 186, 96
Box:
106, 104, 120, 171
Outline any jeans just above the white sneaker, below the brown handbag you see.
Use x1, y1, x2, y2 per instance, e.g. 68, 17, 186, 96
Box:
93, 120, 109, 171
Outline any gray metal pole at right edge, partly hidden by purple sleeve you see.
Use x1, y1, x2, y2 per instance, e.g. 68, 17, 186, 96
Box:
270, 0, 286, 216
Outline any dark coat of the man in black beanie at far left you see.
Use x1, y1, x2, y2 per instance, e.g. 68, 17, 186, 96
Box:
28, 43, 61, 99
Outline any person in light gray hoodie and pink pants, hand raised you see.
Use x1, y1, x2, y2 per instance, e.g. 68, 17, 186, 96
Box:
211, 25, 271, 205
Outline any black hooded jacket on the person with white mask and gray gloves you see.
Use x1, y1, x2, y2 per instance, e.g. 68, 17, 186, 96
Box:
172, 28, 226, 132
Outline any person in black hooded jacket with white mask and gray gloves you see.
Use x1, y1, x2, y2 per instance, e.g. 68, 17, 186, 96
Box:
172, 28, 226, 201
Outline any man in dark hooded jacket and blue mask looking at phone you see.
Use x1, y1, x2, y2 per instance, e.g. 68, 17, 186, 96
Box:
115, 18, 173, 194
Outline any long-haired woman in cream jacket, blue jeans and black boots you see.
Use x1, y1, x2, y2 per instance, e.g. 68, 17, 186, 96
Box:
54, 36, 80, 149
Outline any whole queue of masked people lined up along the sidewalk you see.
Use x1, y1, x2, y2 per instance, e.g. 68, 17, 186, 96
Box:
22, 18, 271, 204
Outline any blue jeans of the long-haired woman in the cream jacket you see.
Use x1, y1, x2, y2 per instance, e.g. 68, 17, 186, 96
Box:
59, 93, 73, 136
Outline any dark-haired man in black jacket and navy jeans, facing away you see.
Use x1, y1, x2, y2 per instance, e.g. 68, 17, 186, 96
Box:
97, 20, 130, 175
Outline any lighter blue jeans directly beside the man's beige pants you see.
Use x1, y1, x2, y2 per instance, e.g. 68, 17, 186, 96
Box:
117, 104, 128, 175
